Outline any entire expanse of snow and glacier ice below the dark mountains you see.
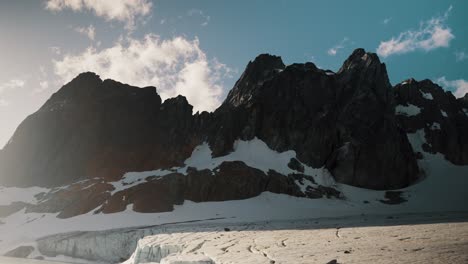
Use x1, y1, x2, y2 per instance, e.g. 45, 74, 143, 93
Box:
0, 135, 468, 264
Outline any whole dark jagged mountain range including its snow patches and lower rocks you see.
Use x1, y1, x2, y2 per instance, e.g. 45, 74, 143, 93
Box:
0, 49, 468, 218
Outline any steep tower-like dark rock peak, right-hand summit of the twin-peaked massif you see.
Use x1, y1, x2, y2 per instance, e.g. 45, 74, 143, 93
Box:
327, 49, 418, 189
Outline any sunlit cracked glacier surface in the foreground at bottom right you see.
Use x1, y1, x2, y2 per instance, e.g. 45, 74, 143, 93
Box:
124, 217, 468, 264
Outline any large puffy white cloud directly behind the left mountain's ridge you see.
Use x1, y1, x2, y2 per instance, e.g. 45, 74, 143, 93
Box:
53, 34, 231, 111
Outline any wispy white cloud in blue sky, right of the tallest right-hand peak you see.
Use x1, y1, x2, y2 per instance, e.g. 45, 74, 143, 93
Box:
377, 6, 455, 57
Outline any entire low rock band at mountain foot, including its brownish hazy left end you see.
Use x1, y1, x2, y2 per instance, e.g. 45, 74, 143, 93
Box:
27, 161, 342, 218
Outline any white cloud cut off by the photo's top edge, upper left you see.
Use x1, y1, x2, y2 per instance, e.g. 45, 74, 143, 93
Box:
45, 0, 152, 28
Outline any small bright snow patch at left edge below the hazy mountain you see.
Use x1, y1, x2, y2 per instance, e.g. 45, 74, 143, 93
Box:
0, 186, 50, 206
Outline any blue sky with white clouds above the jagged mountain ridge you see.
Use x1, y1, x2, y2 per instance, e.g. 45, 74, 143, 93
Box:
0, 0, 468, 148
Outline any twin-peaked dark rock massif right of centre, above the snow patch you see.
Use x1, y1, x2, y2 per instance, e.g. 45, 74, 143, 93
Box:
209, 49, 418, 189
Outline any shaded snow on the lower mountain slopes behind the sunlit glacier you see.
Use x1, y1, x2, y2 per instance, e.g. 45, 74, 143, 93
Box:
0, 137, 468, 263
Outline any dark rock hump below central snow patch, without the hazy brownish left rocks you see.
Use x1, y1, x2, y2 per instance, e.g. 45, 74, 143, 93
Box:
99, 161, 339, 217
